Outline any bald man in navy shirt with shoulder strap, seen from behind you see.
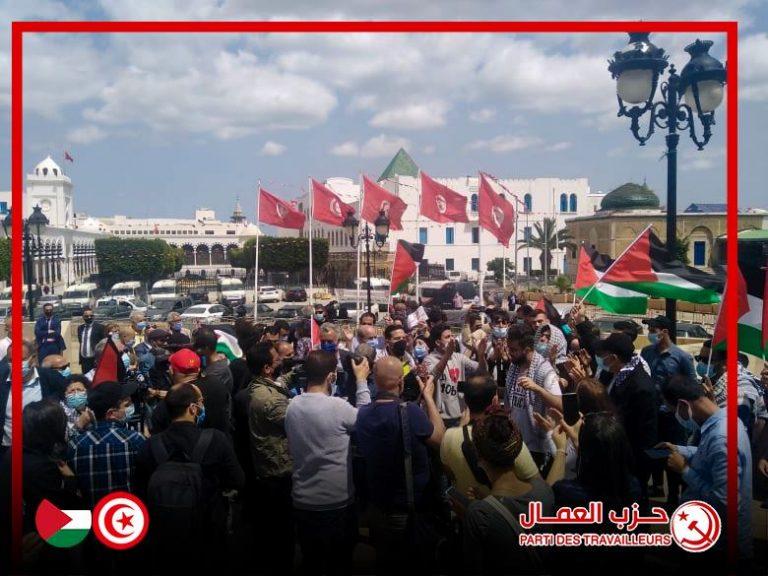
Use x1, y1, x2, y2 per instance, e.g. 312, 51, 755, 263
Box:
355, 357, 445, 573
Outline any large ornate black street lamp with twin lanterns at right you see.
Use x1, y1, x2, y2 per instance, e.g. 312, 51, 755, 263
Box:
608, 32, 726, 340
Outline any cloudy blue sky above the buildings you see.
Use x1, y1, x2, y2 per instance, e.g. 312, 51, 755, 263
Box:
0, 0, 768, 217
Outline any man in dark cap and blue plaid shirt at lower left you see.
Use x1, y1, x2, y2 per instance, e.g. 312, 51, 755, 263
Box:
67, 382, 144, 507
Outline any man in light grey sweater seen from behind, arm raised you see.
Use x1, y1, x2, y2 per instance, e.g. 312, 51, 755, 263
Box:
285, 350, 371, 574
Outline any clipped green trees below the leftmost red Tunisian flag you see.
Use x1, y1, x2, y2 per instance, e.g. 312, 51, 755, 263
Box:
229, 236, 328, 272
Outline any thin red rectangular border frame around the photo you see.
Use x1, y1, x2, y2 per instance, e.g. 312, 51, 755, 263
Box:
11, 21, 738, 570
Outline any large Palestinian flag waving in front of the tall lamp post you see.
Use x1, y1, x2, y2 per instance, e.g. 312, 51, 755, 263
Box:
600, 226, 725, 304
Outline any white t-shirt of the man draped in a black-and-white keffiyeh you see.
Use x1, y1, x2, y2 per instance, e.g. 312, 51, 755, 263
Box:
504, 352, 562, 452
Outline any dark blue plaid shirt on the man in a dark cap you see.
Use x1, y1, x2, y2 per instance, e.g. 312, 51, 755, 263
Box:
69, 421, 145, 506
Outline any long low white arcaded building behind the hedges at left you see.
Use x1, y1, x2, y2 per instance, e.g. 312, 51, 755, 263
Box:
90, 202, 260, 273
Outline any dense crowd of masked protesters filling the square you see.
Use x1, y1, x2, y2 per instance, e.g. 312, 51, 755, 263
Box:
0, 294, 768, 574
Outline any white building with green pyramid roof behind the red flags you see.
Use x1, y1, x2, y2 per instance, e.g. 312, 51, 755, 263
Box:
281, 149, 604, 274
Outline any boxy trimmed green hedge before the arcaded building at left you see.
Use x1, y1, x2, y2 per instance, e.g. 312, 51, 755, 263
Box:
94, 238, 184, 284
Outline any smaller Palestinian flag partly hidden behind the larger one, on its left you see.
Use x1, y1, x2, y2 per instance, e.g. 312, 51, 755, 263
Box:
575, 246, 648, 314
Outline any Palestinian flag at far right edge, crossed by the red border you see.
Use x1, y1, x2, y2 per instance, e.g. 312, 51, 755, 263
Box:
712, 261, 768, 358
